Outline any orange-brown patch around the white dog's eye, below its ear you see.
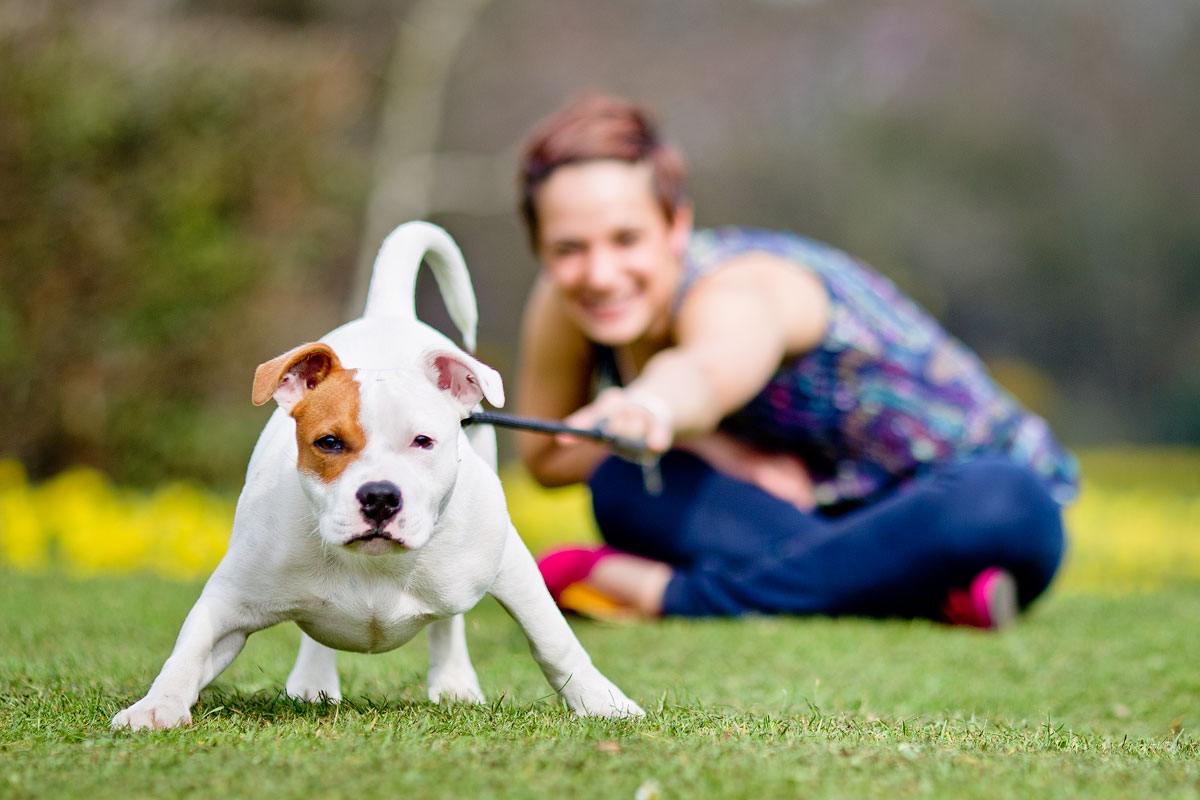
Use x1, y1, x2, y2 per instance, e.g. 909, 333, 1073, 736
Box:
292, 369, 367, 483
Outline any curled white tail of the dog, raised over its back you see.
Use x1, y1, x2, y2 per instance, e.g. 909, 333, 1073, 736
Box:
362, 222, 479, 353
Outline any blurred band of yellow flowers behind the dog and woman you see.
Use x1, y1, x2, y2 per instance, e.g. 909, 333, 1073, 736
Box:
0, 449, 1200, 593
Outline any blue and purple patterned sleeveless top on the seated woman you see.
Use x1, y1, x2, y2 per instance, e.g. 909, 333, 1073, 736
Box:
676, 228, 1079, 505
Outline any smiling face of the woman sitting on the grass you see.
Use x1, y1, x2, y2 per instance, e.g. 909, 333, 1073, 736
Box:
535, 161, 691, 347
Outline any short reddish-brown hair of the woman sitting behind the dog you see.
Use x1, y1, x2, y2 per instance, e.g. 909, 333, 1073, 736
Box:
518, 94, 686, 249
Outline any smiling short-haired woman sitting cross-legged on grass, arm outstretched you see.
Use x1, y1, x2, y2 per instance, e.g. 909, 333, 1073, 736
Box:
517, 96, 1078, 627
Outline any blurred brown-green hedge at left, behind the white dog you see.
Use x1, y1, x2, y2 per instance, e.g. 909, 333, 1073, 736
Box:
0, 6, 368, 483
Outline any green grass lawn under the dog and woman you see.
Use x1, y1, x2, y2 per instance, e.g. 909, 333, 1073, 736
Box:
0, 571, 1200, 799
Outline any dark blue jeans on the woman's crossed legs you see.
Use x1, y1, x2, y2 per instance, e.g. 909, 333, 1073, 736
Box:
589, 451, 1063, 619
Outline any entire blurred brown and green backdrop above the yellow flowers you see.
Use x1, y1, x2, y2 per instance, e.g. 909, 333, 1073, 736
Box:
0, 0, 1200, 491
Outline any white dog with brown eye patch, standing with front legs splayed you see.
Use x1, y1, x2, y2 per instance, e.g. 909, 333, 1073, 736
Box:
113, 223, 642, 729
